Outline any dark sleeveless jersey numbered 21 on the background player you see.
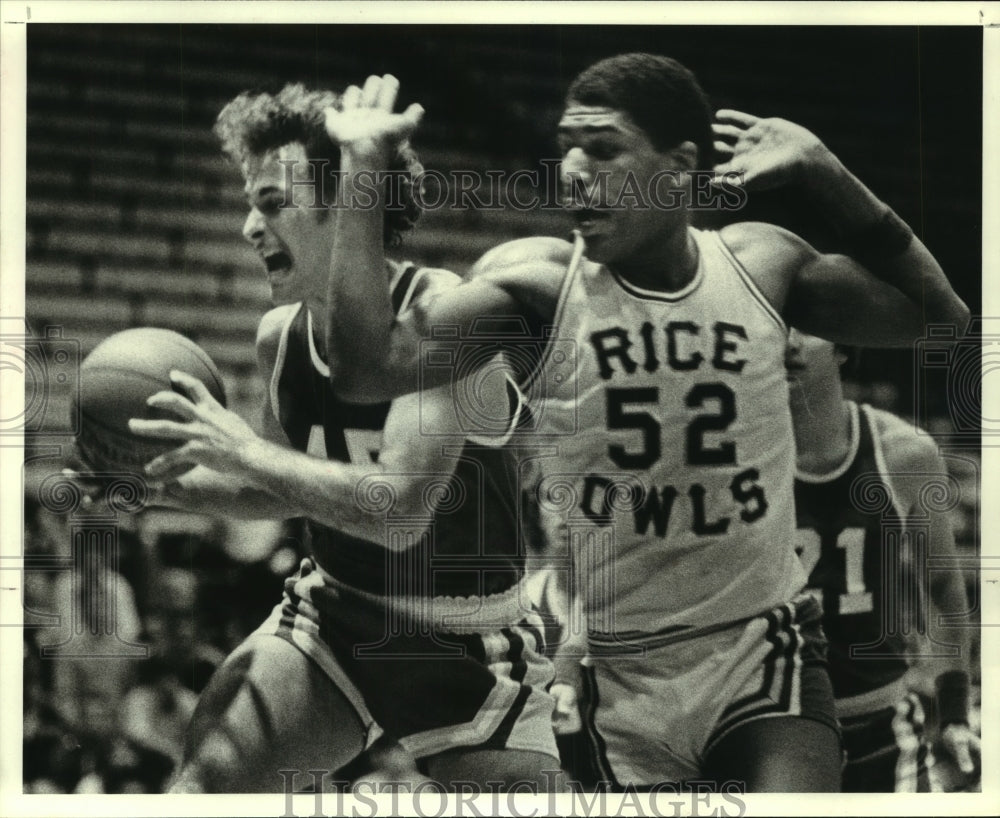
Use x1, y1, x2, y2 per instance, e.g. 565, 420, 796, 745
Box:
795, 403, 914, 699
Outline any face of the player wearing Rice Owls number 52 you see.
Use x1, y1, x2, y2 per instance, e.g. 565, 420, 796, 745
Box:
558, 101, 686, 264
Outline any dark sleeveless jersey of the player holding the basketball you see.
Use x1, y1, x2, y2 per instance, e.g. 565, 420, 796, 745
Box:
270, 267, 523, 596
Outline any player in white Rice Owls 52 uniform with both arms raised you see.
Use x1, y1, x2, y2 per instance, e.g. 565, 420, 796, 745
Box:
320, 59, 968, 792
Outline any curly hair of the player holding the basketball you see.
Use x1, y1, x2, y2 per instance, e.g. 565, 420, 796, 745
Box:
213, 83, 424, 247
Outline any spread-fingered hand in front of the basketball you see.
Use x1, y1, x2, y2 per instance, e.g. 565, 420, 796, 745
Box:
128, 370, 259, 482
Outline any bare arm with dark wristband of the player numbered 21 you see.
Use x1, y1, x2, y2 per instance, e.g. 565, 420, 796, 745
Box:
876, 413, 980, 774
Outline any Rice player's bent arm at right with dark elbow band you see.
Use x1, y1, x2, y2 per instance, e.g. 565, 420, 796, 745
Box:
713, 110, 969, 346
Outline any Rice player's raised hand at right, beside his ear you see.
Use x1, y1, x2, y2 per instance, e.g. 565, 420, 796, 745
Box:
712, 109, 830, 190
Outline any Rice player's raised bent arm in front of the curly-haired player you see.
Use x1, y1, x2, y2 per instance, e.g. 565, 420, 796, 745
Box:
327, 77, 571, 402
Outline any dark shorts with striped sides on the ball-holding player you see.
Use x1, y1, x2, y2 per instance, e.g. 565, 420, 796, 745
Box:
255, 558, 558, 758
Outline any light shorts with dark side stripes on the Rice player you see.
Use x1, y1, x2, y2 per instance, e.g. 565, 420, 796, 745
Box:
583, 595, 838, 786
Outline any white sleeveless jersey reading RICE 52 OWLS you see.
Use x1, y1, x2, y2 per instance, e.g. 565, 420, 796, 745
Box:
533, 229, 806, 645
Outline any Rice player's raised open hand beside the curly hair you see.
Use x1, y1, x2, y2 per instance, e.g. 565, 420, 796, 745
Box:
326, 74, 424, 170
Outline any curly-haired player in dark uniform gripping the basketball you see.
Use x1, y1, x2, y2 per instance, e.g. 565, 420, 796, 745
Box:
124, 86, 558, 792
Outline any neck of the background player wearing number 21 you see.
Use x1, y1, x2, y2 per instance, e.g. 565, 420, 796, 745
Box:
792, 385, 851, 474
